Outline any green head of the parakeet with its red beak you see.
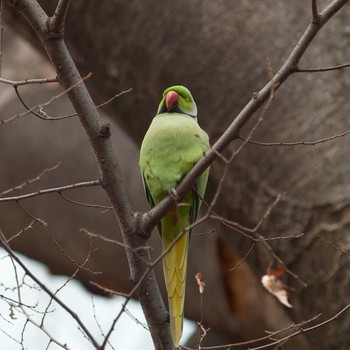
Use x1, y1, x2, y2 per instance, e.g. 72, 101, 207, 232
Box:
157, 85, 197, 119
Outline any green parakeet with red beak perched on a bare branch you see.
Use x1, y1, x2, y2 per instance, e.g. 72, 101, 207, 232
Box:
140, 86, 210, 348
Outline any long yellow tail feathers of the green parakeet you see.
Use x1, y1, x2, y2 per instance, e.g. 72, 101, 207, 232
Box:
162, 232, 189, 348
